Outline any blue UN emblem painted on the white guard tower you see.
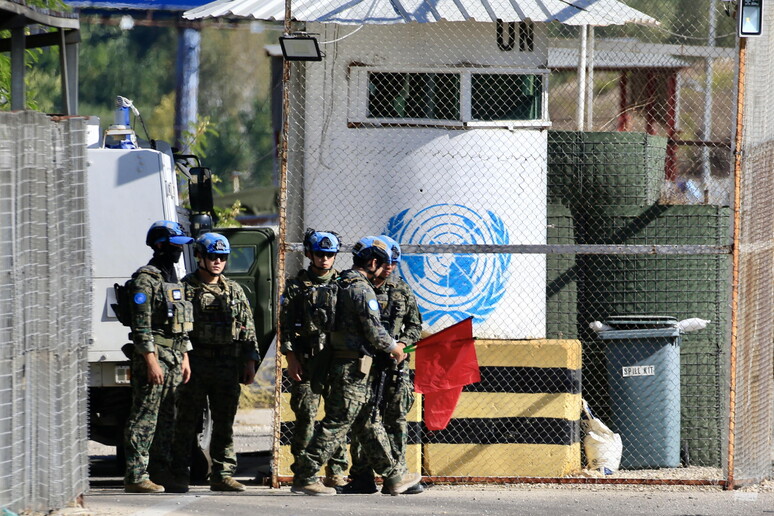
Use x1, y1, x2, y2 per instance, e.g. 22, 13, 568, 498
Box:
385, 204, 511, 326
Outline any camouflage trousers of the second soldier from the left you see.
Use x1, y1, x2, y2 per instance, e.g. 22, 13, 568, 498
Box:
173, 349, 244, 482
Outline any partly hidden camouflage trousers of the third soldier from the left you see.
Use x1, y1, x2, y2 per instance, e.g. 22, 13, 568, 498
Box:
290, 369, 349, 476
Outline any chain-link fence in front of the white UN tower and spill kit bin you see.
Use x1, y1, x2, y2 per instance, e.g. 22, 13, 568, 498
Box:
215, 0, 772, 483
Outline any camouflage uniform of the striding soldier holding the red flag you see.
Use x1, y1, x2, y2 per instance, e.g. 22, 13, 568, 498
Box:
293, 270, 402, 486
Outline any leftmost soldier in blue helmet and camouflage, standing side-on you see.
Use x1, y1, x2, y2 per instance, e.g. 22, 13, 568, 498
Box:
124, 220, 193, 493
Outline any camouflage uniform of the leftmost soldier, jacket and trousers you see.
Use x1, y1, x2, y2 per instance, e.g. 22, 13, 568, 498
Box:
124, 265, 192, 484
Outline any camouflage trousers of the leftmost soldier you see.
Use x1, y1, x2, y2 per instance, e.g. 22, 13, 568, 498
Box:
124, 346, 183, 484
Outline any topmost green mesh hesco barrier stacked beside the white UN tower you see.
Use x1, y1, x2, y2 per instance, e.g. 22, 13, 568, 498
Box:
548, 131, 667, 206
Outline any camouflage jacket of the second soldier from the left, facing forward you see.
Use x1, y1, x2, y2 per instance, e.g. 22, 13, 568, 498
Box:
183, 272, 260, 360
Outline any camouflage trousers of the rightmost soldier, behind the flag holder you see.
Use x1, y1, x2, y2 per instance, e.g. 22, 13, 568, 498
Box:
349, 362, 414, 478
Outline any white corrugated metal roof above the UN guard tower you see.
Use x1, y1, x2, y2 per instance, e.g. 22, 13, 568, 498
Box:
183, 0, 658, 26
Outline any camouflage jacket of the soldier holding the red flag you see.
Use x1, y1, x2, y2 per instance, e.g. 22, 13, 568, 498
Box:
331, 269, 396, 354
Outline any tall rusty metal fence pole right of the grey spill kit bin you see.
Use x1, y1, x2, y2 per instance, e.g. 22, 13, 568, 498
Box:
726, 34, 747, 489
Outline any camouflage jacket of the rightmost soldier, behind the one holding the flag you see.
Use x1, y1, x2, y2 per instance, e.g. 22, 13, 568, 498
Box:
374, 275, 422, 346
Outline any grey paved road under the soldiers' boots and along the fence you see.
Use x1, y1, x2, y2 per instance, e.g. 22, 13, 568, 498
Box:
80, 411, 774, 516
